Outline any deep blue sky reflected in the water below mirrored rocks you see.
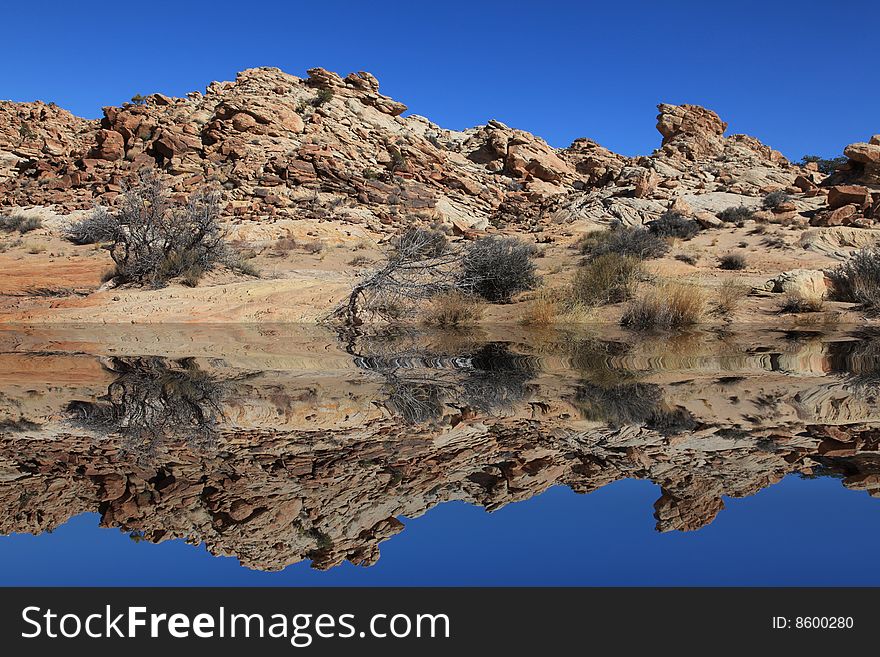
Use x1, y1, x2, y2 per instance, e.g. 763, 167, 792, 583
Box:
0, 476, 880, 586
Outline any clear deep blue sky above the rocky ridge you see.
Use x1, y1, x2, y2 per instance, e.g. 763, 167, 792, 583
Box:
0, 0, 880, 157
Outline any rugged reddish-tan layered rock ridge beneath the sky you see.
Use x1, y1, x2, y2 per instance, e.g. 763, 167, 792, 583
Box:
0, 68, 820, 235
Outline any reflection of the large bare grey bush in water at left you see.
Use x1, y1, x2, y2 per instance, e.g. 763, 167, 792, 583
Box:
67, 357, 223, 453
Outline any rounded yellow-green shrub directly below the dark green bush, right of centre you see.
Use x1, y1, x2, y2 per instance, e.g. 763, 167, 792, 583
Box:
571, 253, 645, 306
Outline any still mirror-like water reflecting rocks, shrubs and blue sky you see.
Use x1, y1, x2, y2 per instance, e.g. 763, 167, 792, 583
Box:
0, 326, 880, 585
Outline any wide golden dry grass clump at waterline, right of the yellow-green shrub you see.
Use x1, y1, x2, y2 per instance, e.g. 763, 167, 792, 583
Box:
620, 283, 706, 331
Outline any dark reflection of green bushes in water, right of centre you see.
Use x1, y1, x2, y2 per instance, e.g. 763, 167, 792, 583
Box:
574, 382, 697, 435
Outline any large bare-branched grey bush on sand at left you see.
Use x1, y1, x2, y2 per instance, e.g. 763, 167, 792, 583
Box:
104, 169, 229, 287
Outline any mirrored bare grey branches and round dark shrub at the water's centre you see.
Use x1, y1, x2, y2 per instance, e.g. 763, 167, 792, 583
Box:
376, 342, 538, 424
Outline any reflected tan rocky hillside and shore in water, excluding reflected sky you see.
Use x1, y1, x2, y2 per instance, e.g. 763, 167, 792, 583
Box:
0, 327, 880, 570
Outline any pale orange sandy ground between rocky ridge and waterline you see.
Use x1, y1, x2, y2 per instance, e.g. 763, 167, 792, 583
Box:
0, 209, 880, 326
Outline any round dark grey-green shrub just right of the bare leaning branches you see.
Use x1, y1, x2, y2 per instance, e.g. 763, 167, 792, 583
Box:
458, 236, 538, 301
